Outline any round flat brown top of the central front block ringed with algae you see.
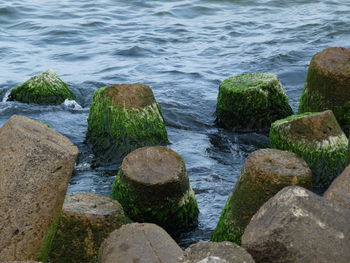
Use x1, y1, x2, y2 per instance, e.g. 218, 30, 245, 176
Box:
122, 146, 185, 185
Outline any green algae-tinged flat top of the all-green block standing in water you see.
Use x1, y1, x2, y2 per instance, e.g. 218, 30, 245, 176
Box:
221, 73, 278, 91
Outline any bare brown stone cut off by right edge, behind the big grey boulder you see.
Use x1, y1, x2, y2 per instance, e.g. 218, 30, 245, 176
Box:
324, 166, 350, 208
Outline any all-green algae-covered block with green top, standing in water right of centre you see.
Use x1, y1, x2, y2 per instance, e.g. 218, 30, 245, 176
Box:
216, 73, 293, 132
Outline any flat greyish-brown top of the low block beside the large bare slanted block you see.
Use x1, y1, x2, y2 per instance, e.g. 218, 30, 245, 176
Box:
63, 193, 122, 216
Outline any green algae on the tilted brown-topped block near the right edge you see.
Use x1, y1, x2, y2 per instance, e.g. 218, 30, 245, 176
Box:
269, 113, 348, 193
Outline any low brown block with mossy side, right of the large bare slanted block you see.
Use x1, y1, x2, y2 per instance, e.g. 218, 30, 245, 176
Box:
49, 193, 129, 263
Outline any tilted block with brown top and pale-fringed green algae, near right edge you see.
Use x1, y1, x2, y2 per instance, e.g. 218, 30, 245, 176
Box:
270, 110, 348, 193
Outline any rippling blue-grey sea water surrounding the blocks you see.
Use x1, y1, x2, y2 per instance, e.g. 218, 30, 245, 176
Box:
0, 0, 350, 248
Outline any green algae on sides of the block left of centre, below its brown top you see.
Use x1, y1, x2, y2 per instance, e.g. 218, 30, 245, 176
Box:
87, 87, 168, 162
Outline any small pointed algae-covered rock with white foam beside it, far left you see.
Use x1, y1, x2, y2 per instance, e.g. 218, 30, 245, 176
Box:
8, 70, 75, 105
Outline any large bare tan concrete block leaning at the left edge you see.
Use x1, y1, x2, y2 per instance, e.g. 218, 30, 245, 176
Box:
0, 115, 78, 261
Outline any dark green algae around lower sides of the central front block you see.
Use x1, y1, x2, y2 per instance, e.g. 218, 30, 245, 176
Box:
111, 173, 199, 235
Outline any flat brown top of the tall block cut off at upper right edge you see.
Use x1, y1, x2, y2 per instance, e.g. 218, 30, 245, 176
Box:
313, 47, 350, 78
